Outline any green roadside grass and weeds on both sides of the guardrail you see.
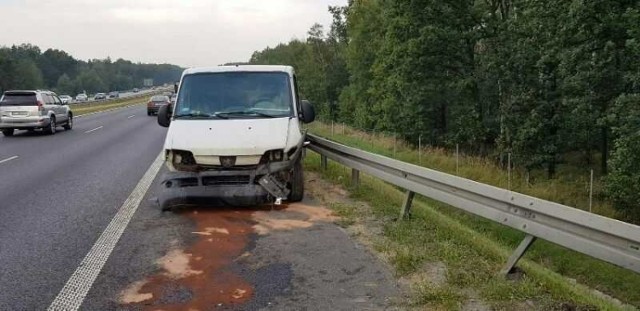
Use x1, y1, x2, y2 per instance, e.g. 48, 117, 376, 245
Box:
307, 123, 640, 310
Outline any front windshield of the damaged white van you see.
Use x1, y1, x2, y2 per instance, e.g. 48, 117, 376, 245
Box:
175, 72, 293, 119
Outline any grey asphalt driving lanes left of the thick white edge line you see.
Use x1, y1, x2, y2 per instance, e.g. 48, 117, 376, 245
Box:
0, 106, 166, 310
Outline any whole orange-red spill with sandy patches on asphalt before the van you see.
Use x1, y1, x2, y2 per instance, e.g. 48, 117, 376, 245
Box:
118, 204, 335, 311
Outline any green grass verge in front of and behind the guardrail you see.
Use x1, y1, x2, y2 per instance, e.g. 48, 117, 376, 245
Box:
307, 126, 640, 309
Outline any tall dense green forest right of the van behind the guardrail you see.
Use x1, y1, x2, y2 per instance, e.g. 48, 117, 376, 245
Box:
250, 0, 640, 222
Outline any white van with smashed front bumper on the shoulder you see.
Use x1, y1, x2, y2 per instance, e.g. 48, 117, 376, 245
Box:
158, 66, 315, 210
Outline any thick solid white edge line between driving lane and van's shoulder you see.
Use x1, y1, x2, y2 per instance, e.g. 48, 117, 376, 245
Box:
48, 153, 163, 311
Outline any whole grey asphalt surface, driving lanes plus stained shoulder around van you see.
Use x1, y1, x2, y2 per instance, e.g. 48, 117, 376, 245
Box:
0, 106, 400, 310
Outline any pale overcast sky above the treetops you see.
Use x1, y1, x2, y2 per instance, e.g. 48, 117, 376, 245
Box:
0, 0, 348, 67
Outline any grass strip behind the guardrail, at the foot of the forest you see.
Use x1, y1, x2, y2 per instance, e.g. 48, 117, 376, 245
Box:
309, 122, 617, 218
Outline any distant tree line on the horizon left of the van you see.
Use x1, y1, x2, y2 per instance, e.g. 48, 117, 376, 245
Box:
0, 44, 184, 96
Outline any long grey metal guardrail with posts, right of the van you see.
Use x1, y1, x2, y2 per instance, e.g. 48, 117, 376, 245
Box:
307, 134, 640, 274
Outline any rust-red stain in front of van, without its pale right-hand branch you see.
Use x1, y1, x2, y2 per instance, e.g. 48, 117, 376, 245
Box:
120, 209, 264, 311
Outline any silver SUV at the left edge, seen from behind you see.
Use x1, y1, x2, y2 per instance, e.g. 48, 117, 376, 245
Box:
0, 90, 73, 136
